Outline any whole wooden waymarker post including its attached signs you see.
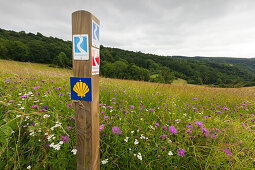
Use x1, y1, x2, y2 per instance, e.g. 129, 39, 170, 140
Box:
70, 10, 100, 170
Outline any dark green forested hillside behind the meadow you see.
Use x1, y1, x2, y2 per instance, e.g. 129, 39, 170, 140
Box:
0, 29, 255, 87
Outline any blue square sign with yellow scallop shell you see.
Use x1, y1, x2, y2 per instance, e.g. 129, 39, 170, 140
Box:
70, 77, 92, 101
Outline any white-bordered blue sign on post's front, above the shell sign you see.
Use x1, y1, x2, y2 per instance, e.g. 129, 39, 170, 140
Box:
73, 34, 89, 60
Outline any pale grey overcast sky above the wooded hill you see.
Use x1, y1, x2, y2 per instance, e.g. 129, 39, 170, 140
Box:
0, 0, 255, 58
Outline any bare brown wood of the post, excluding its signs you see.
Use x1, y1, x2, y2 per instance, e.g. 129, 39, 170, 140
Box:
72, 11, 100, 170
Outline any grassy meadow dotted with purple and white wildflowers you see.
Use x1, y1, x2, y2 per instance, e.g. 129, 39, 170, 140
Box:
0, 60, 255, 169
